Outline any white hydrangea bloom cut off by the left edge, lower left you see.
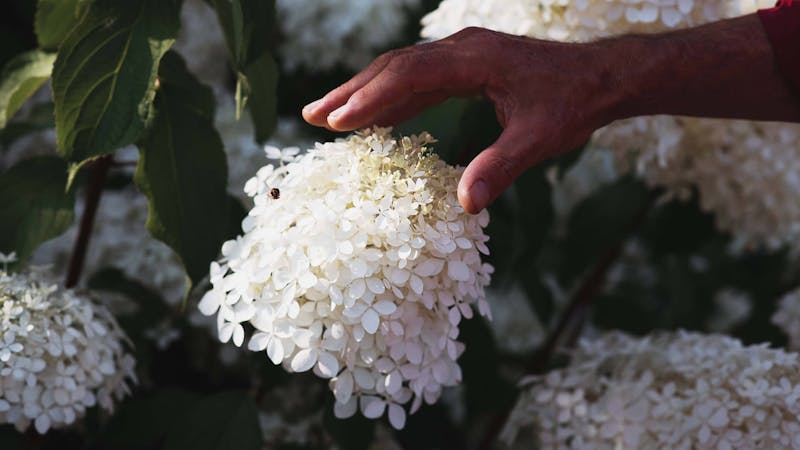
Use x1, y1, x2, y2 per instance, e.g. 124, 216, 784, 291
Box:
0, 268, 136, 433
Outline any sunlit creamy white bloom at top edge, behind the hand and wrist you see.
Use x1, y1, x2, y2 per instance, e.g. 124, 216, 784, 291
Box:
421, 0, 740, 42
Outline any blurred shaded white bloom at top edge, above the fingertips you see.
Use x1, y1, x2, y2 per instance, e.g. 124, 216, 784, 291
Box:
275, 0, 419, 71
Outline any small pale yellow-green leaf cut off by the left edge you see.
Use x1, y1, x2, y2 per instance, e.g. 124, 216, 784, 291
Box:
0, 50, 56, 128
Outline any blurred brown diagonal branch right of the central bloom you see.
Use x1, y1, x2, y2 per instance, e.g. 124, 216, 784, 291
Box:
478, 190, 661, 450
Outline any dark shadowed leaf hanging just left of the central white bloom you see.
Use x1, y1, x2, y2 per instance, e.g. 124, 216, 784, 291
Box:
134, 52, 230, 284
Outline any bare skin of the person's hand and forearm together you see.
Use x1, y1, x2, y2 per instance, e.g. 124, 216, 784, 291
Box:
303, 14, 800, 213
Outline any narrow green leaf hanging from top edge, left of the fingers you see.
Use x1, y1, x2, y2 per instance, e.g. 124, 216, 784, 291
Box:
210, 0, 278, 142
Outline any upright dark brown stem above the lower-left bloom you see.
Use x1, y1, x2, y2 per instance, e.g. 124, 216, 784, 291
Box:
65, 156, 114, 288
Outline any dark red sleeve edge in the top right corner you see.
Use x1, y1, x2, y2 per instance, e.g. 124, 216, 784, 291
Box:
758, 0, 800, 94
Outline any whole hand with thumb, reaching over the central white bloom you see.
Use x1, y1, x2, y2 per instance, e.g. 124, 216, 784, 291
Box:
303, 28, 617, 213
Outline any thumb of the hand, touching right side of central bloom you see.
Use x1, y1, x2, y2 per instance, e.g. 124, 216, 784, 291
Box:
458, 122, 540, 214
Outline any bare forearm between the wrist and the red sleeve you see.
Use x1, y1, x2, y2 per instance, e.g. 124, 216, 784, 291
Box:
604, 14, 800, 122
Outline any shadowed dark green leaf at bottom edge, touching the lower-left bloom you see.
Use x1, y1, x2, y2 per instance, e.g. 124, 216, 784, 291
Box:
99, 389, 201, 450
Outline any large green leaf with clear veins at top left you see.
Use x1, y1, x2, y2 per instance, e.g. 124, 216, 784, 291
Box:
53, 0, 180, 166
